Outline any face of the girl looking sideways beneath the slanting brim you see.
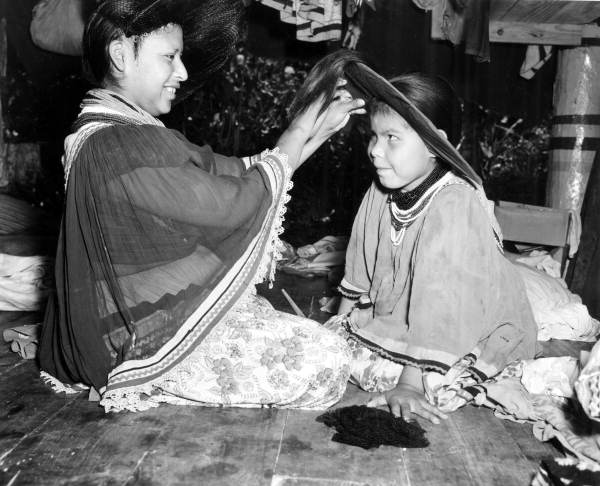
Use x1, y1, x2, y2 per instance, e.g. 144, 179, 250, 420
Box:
368, 110, 435, 191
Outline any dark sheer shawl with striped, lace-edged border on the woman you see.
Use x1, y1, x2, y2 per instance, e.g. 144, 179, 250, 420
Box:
40, 90, 291, 410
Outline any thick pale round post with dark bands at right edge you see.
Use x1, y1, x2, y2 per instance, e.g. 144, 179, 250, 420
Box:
546, 46, 600, 211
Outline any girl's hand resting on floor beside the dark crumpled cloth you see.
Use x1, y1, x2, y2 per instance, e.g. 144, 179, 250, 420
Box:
367, 383, 448, 424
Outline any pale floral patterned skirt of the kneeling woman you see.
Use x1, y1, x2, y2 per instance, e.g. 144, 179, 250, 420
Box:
152, 296, 351, 409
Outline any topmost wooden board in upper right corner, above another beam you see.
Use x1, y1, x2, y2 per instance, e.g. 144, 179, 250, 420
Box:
490, 0, 600, 24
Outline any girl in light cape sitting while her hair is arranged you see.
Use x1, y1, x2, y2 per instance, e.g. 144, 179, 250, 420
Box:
292, 54, 536, 423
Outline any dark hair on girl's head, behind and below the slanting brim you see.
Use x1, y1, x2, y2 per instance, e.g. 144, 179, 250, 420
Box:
369, 73, 461, 146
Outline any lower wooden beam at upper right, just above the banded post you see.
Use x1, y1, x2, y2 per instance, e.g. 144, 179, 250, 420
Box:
490, 20, 583, 46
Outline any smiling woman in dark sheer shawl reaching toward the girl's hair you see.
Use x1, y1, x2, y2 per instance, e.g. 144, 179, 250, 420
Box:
40, 0, 362, 411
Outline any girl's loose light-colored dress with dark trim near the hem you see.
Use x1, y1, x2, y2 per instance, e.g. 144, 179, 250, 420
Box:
341, 173, 536, 391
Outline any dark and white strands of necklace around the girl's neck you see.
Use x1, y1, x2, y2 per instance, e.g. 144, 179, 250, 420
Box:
388, 164, 448, 246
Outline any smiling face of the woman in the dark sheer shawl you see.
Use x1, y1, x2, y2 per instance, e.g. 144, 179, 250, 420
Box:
120, 24, 187, 116
